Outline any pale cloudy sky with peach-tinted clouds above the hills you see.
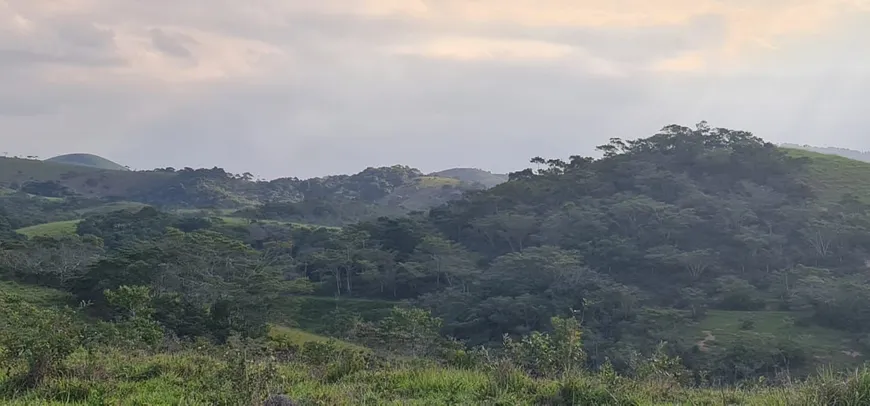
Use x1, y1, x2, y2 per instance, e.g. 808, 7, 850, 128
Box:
0, 0, 870, 178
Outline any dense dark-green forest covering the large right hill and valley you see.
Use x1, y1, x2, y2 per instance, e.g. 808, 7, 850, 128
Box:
0, 123, 870, 400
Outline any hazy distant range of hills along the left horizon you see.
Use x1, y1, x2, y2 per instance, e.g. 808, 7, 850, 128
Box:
0, 157, 491, 226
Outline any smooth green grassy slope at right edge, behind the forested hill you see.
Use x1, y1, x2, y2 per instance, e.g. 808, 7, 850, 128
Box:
786, 148, 870, 203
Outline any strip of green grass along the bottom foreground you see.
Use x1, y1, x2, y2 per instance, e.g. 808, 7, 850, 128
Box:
0, 349, 870, 406
